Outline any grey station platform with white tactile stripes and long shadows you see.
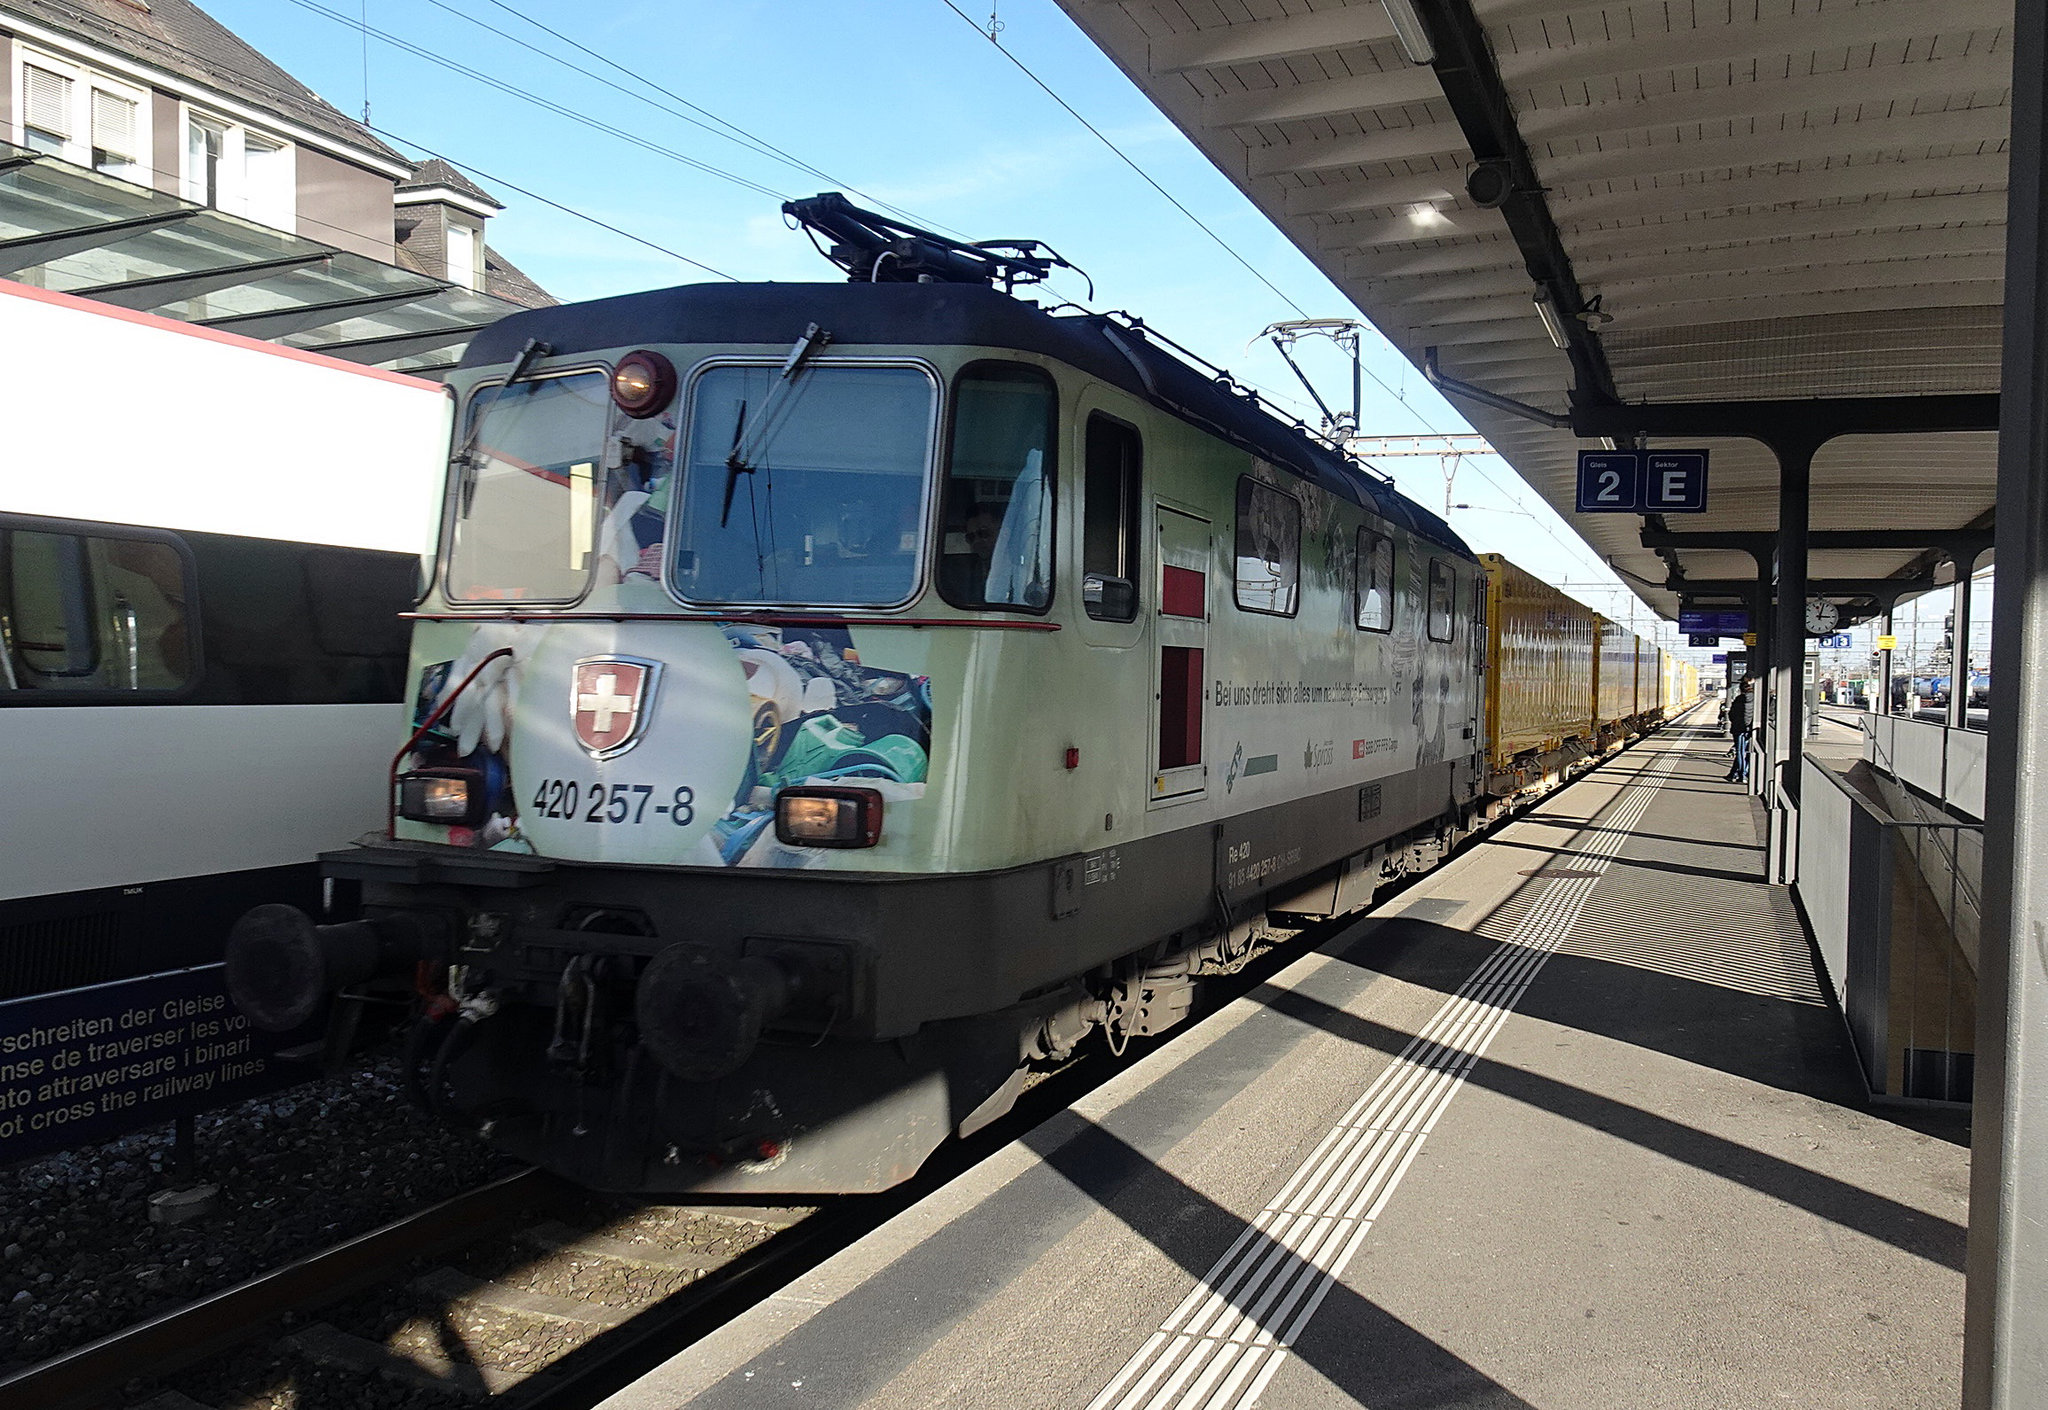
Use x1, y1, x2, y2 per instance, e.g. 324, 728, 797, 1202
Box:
606, 709, 1968, 1410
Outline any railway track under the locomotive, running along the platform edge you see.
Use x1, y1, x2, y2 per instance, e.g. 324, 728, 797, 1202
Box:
0, 770, 1646, 1410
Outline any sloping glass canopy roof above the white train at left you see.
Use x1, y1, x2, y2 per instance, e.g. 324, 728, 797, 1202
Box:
0, 141, 520, 377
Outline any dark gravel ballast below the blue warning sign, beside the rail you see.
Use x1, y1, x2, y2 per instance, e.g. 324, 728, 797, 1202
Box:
0, 1058, 514, 1375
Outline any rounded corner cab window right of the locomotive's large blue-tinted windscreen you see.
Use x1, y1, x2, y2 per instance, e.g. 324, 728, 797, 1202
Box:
938, 363, 1059, 613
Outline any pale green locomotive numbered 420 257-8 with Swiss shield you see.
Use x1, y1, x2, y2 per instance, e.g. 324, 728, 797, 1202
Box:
229, 199, 1677, 1193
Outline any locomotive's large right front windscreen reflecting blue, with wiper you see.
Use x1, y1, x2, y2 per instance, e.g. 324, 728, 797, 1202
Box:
672, 363, 933, 607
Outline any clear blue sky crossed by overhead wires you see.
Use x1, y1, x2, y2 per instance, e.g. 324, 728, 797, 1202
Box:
201, 0, 1649, 627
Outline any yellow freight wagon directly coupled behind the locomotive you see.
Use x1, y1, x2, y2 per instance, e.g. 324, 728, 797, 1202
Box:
1479, 553, 1599, 795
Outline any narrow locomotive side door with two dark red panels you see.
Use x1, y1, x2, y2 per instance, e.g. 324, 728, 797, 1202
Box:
1147, 502, 1214, 807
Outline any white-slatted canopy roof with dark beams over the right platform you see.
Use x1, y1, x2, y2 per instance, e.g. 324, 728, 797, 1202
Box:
1061, 0, 2013, 613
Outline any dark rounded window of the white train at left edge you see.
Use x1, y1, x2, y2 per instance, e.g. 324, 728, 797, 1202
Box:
0, 529, 193, 695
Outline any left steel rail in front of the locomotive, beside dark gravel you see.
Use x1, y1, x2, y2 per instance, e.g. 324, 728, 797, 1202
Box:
0, 1170, 571, 1410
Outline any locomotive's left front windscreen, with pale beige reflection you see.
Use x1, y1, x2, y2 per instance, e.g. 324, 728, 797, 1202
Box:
449, 371, 610, 603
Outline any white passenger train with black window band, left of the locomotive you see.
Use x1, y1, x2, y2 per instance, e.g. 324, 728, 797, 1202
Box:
0, 281, 449, 998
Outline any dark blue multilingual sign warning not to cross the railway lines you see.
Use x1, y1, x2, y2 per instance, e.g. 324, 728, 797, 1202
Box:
0, 965, 319, 1166
